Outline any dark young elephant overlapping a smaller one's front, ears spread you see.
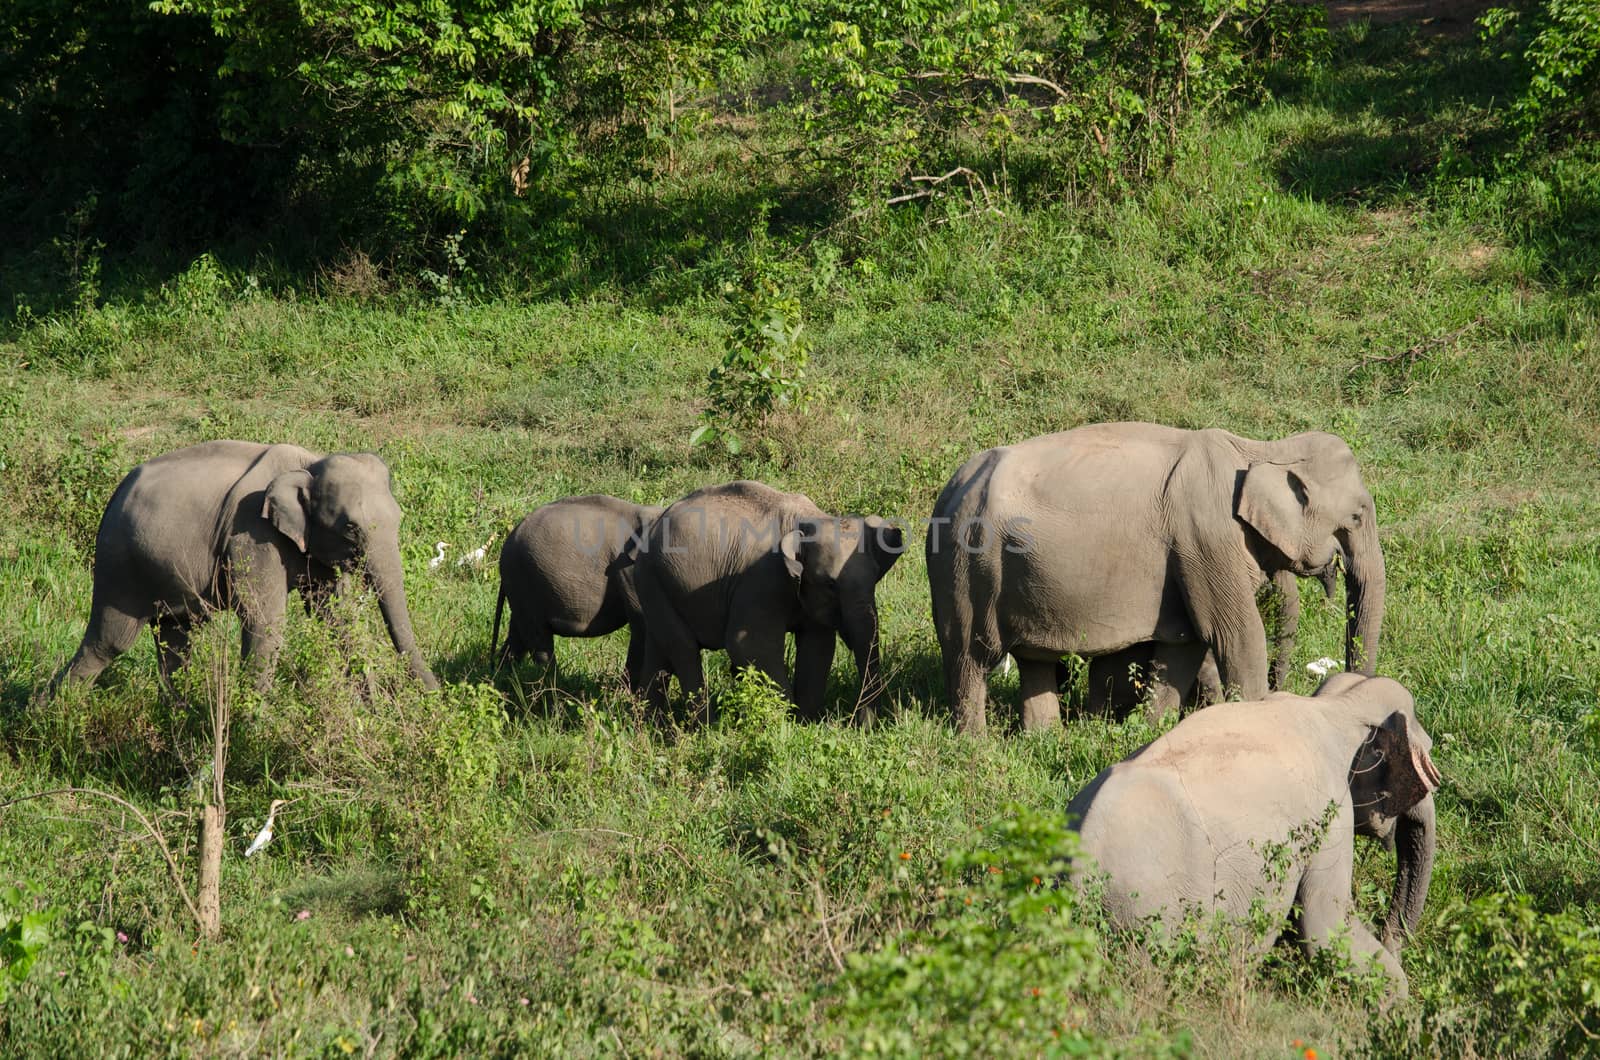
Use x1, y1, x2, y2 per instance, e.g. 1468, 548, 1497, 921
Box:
624, 480, 902, 724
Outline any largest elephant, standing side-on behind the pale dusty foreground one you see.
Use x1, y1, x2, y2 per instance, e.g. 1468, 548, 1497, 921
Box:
926, 423, 1384, 733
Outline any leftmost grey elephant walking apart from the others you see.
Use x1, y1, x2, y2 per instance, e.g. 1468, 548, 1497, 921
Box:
51, 442, 438, 692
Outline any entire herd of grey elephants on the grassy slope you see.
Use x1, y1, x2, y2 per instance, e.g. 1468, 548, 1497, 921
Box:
40, 423, 1440, 991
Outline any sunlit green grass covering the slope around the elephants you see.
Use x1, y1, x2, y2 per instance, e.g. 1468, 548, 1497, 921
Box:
0, 18, 1600, 1057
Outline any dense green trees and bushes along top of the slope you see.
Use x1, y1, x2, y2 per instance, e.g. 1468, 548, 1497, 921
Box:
0, 0, 1317, 279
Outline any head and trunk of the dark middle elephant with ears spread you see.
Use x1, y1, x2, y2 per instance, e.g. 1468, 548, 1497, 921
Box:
781, 516, 904, 711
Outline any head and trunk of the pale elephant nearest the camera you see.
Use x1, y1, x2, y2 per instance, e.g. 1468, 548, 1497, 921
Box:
1317, 674, 1440, 953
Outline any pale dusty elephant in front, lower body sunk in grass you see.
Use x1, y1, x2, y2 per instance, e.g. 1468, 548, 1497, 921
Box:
1067, 673, 1440, 996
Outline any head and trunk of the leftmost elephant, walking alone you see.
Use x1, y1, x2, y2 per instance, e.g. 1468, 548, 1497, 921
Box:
261, 453, 438, 689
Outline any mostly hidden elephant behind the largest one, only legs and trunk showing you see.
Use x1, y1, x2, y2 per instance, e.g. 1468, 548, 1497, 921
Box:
1081, 560, 1341, 721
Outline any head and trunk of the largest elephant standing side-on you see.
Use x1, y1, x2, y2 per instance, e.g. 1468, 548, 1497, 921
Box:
1235, 432, 1386, 674
